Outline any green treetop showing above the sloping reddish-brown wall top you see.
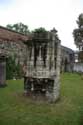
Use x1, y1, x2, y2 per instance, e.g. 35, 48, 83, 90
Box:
6, 23, 29, 35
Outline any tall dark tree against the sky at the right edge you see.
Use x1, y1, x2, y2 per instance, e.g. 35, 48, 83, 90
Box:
73, 14, 83, 49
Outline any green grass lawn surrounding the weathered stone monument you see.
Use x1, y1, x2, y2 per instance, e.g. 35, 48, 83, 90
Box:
0, 73, 83, 125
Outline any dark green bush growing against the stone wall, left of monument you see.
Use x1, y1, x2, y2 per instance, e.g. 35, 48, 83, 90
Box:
6, 56, 22, 79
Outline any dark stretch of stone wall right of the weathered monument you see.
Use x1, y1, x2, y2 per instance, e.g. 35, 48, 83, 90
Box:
61, 46, 75, 72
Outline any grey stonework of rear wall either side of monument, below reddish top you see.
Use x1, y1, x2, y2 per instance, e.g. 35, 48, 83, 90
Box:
0, 40, 74, 72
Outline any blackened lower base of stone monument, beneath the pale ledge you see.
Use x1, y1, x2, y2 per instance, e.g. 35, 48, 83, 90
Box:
24, 77, 58, 102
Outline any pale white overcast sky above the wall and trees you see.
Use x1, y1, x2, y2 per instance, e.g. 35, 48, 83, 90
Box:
0, 0, 83, 50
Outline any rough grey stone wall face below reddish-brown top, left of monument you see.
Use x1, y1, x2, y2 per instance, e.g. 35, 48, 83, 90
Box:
0, 40, 26, 64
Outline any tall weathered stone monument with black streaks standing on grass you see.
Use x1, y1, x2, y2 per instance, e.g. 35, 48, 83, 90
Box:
24, 29, 61, 102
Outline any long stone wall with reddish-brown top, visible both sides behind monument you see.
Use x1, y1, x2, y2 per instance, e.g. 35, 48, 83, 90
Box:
0, 26, 74, 71
